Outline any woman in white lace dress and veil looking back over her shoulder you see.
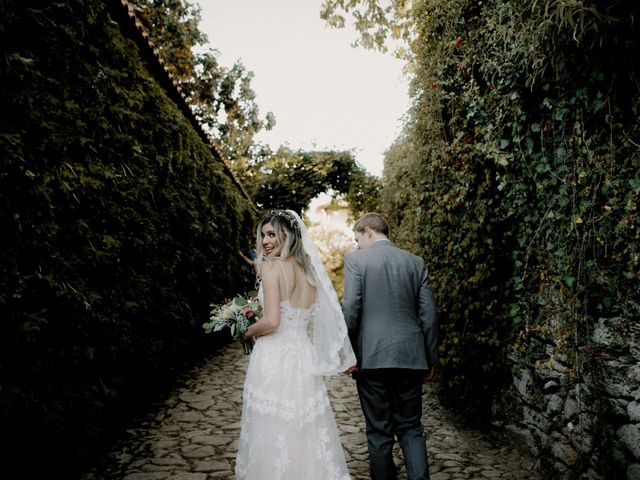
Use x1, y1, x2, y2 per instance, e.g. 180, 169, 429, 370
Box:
235, 210, 356, 480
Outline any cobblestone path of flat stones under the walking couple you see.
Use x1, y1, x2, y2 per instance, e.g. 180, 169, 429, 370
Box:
81, 343, 542, 480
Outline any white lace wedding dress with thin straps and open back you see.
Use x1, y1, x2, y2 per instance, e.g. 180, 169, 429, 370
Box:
236, 284, 350, 480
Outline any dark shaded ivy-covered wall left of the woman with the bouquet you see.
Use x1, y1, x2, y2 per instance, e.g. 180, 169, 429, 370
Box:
0, 0, 254, 472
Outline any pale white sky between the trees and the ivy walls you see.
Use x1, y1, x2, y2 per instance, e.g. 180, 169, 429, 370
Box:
195, 0, 409, 176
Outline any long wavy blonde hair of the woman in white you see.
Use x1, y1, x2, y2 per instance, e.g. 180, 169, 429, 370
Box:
256, 210, 318, 286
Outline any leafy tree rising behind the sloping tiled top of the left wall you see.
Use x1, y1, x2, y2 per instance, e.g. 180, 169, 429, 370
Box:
133, 0, 275, 162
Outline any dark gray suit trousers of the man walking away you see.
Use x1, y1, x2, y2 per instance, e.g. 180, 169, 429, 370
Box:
355, 368, 429, 480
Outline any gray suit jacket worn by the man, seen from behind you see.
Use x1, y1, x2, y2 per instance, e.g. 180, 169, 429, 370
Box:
342, 240, 438, 370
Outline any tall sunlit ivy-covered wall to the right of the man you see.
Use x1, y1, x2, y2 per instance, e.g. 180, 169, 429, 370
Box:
383, 0, 640, 478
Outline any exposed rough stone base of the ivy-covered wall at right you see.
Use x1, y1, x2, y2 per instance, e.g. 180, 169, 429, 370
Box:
514, 317, 640, 480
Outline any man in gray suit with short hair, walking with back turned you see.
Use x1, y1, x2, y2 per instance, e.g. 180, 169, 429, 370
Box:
342, 213, 438, 480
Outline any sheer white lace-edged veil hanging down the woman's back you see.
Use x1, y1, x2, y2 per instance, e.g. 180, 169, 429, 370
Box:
287, 210, 356, 375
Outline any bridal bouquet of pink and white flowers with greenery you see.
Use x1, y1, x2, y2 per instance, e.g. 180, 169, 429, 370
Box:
202, 292, 262, 355
